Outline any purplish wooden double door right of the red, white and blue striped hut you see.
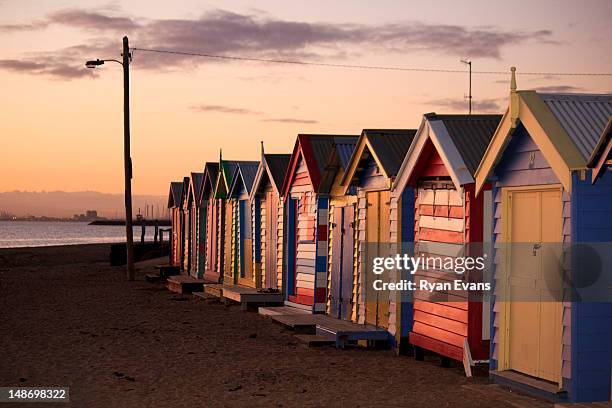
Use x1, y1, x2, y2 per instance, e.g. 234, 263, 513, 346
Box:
330, 206, 354, 320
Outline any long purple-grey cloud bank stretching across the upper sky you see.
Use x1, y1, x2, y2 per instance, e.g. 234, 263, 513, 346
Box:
0, 9, 553, 78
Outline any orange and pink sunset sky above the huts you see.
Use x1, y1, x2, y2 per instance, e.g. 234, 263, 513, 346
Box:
0, 0, 612, 194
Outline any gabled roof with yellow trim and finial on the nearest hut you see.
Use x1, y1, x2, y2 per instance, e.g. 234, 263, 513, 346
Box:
476, 85, 612, 192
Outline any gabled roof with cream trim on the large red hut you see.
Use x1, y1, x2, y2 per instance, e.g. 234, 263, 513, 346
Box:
393, 113, 502, 190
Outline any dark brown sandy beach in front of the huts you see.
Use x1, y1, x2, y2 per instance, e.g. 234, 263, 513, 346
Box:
0, 245, 552, 408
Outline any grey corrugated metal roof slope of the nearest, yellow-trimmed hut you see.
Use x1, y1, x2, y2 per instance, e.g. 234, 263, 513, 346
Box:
538, 92, 612, 161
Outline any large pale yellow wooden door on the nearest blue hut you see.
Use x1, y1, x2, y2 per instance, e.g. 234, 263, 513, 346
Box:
506, 189, 563, 382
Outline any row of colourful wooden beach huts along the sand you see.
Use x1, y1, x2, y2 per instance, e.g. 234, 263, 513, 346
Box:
160, 71, 612, 402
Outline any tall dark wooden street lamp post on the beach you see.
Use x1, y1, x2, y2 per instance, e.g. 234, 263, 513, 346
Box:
85, 36, 135, 281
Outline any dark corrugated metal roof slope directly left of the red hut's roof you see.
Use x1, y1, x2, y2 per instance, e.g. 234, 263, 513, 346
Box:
362, 129, 417, 177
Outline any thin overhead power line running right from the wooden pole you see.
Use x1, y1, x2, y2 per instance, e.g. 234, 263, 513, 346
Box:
131, 47, 612, 76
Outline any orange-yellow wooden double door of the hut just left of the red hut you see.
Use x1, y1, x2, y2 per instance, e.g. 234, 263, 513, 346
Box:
364, 191, 390, 328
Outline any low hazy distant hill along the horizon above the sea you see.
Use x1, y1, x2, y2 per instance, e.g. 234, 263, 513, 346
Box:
0, 191, 167, 218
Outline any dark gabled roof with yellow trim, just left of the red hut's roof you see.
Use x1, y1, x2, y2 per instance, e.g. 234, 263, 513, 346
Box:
341, 129, 416, 192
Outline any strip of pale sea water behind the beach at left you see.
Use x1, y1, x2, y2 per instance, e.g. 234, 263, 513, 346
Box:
0, 221, 163, 248
